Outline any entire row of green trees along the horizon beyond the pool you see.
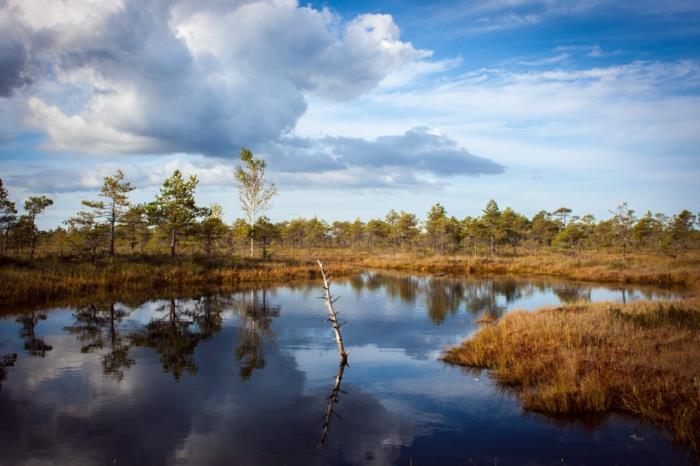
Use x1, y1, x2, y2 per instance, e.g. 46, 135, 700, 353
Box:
0, 149, 700, 259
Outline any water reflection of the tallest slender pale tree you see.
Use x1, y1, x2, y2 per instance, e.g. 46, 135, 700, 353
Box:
234, 288, 280, 379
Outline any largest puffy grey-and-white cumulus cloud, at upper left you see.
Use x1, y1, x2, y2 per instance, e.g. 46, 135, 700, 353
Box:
0, 0, 431, 155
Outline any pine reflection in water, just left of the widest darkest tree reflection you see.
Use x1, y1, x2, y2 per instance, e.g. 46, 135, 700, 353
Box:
64, 301, 134, 380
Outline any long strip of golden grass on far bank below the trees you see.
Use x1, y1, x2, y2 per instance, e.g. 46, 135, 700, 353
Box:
0, 248, 700, 305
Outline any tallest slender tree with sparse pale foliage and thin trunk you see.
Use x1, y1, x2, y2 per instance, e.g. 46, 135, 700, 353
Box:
235, 149, 277, 256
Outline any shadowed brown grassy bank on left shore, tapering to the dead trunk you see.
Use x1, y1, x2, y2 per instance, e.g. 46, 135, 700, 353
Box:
0, 256, 359, 306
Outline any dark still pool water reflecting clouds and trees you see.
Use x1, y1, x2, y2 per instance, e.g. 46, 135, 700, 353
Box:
0, 272, 692, 465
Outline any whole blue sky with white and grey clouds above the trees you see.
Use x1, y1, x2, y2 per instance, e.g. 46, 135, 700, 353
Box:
0, 0, 700, 228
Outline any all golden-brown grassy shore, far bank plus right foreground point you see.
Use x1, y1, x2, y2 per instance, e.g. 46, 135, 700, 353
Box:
0, 250, 700, 454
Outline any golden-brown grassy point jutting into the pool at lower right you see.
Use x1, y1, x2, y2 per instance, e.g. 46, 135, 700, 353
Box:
444, 298, 700, 453
